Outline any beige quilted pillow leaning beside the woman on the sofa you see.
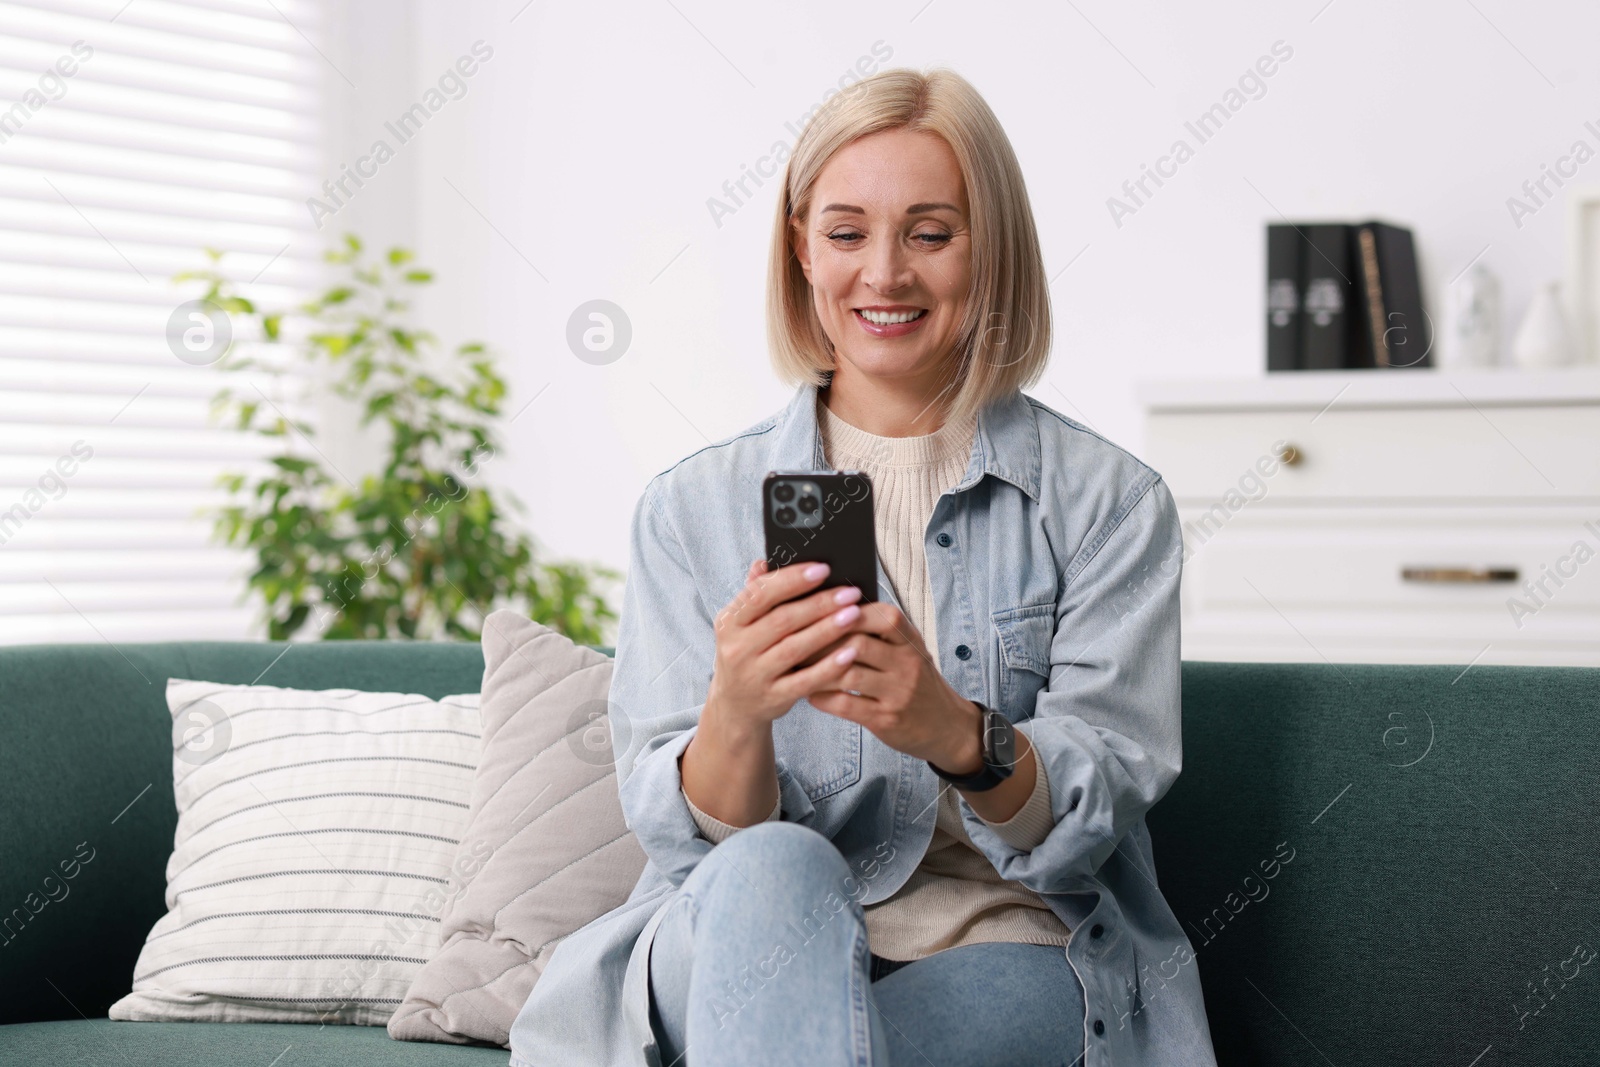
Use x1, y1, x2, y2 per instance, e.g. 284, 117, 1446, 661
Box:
389, 611, 645, 1046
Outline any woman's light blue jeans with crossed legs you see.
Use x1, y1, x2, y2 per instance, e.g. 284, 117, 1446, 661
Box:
650, 822, 1085, 1067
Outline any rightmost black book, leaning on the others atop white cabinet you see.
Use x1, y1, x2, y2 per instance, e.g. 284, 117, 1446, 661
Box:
1349, 222, 1434, 366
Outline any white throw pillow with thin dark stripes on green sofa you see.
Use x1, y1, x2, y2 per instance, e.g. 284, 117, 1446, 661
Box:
110, 678, 480, 1025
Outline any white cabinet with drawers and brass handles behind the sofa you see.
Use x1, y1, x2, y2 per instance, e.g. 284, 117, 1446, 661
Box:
1141, 370, 1600, 665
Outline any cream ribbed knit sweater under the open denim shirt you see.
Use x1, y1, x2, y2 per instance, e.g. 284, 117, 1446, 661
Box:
685, 402, 1070, 960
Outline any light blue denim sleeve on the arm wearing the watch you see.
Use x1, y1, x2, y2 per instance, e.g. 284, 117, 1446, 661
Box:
963, 472, 1184, 893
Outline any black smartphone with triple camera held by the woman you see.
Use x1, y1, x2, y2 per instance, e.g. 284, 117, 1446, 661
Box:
762, 470, 878, 603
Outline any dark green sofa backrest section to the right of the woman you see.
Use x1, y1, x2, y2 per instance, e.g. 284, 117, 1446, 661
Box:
1149, 662, 1600, 1067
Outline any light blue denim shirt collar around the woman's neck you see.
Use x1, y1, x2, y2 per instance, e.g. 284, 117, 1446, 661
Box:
768, 382, 1040, 504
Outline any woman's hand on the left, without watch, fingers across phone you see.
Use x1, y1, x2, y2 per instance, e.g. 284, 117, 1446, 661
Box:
706, 560, 861, 725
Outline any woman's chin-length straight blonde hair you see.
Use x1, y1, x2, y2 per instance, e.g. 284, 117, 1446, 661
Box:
766, 69, 1050, 419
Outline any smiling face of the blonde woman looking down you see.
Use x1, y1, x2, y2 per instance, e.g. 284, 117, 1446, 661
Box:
795, 130, 971, 390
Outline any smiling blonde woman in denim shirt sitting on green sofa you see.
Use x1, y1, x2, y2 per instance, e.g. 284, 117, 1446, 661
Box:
512, 70, 1213, 1067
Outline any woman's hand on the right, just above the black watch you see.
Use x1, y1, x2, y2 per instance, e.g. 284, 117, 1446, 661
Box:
808, 603, 982, 774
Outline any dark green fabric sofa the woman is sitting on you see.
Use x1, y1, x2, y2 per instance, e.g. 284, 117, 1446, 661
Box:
0, 641, 1600, 1067
